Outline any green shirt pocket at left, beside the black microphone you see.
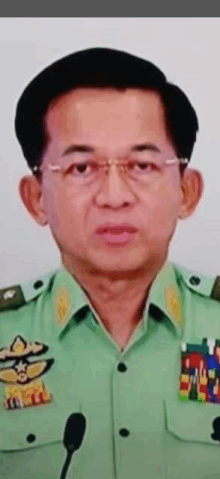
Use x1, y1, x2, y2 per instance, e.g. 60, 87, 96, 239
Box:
0, 402, 83, 479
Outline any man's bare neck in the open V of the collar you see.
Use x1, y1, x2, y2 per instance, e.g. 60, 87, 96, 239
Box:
62, 257, 165, 347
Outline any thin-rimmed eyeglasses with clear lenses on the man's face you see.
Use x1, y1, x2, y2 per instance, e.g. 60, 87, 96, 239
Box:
32, 154, 189, 189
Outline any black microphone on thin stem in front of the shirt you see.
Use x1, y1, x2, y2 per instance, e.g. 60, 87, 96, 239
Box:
60, 412, 86, 479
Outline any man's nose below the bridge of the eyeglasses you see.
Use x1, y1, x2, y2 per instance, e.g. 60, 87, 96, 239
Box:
95, 162, 136, 209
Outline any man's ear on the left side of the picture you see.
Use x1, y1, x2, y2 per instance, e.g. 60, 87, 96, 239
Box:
19, 175, 48, 226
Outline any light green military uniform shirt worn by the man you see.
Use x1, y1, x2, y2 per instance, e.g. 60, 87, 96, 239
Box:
0, 263, 220, 479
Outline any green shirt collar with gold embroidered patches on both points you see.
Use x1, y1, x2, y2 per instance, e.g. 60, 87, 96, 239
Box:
52, 262, 185, 336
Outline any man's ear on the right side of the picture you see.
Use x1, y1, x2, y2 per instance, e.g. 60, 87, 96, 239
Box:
178, 168, 204, 219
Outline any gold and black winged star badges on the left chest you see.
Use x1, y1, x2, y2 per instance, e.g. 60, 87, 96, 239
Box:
0, 336, 54, 409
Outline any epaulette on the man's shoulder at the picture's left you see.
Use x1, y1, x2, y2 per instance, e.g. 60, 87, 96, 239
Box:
0, 270, 57, 312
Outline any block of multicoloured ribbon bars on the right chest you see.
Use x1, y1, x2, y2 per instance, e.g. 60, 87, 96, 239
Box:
179, 338, 220, 404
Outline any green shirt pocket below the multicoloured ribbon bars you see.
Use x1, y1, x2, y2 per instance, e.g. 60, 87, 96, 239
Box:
164, 399, 220, 479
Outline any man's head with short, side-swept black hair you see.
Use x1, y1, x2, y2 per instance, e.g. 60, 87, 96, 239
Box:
16, 49, 202, 275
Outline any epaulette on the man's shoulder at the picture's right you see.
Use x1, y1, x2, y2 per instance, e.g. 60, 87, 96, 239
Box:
175, 265, 220, 301
